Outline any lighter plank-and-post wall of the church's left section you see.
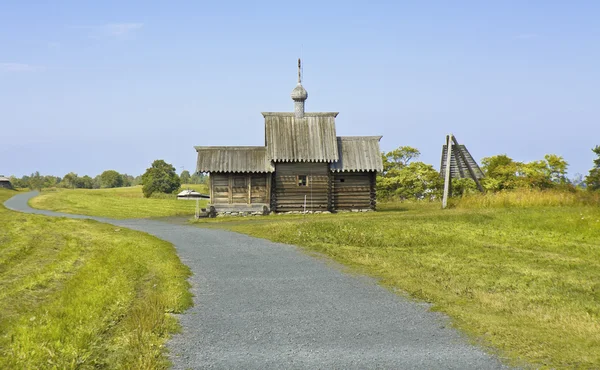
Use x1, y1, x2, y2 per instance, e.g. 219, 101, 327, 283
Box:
210, 173, 271, 204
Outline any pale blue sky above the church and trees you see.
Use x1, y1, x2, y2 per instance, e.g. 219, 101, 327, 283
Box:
0, 1, 600, 176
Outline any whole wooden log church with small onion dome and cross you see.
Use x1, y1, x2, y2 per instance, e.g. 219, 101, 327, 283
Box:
195, 59, 383, 213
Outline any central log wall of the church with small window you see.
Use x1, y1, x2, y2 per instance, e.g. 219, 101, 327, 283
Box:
272, 162, 331, 212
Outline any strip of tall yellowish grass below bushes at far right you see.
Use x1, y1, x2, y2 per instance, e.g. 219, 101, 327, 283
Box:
450, 189, 600, 209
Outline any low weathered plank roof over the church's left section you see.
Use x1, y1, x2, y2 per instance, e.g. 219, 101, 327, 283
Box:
194, 146, 275, 173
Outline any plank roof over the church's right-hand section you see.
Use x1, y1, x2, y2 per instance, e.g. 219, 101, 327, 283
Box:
331, 136, 383, 172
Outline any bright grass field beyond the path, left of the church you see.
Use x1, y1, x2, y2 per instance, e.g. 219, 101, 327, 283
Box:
29, 185, 207, 219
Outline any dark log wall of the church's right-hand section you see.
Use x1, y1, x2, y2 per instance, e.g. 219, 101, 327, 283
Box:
332, 172, 375, 210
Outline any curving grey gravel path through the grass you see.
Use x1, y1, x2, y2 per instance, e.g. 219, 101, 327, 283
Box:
4, 192, 506, 369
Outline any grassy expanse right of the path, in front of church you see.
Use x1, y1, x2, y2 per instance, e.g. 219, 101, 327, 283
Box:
199, 199, 600, 368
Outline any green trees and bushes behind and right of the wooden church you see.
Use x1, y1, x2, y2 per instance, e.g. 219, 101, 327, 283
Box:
377, 146, 600, 200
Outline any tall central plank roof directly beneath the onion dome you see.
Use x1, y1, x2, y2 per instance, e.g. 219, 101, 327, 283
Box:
262, 112, 339, 162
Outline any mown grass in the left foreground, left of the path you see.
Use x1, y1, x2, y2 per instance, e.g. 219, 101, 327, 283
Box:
0, 190, 191, 369
